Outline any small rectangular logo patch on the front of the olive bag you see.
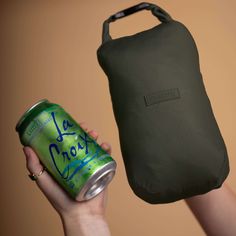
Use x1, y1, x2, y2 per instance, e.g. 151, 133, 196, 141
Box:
144, 88, 180, 106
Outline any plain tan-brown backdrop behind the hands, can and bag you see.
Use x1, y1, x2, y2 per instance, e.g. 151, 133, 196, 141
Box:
0, 0, 236, 236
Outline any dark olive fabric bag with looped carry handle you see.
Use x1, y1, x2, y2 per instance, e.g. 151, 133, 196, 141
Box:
97, 3, 229, 204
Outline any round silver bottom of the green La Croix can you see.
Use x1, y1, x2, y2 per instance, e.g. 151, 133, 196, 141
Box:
75, 161, 116, 202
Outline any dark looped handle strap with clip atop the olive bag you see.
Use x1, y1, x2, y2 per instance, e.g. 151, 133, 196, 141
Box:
102, 2, 172, 43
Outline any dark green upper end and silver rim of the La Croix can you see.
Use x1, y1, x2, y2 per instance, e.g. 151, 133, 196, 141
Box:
15, 99, 49, 133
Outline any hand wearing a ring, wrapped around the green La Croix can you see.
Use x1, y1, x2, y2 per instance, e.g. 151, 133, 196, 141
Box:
23, 122, 111, 236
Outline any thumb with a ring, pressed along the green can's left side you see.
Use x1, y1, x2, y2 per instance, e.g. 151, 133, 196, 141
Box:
23, 147, 71, 212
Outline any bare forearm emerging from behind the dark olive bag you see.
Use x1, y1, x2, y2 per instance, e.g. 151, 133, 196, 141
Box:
185, 185, 236, 236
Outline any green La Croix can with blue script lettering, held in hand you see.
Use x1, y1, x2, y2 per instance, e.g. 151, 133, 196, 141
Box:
16, 99, 116, 201
